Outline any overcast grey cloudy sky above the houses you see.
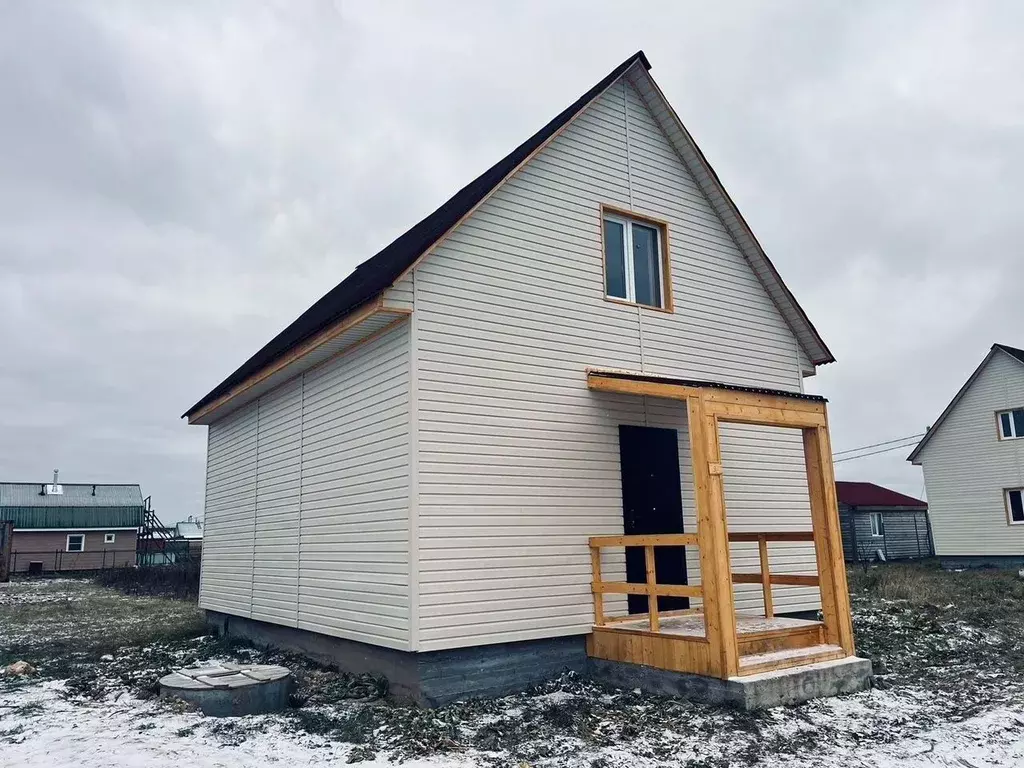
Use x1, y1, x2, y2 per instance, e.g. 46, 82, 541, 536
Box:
0, 0, 1024, 521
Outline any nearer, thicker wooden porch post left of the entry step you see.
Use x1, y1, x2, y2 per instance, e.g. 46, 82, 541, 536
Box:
686, 396, 739, 678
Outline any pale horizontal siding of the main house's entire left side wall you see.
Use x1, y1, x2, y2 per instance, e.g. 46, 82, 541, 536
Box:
200, 323, 410, 648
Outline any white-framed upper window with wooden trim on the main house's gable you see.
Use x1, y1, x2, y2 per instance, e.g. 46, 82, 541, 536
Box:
604, 213, 668, 309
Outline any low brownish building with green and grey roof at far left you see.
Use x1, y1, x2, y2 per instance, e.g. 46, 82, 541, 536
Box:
0, 473, 145, 573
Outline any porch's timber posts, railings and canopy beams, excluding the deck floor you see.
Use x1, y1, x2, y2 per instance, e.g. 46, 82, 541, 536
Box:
587, 369, 854, 678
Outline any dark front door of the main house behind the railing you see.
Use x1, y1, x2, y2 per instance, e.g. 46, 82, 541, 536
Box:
618, 425, 690, 613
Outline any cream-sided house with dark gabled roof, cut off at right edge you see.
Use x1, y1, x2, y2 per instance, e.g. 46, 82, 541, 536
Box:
907, 344, 1024, 567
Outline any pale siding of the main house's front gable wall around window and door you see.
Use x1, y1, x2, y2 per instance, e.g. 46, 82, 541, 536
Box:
416, 76, 817, 650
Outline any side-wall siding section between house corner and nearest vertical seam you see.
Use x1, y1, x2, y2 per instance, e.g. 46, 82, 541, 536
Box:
299, 323, 410, 648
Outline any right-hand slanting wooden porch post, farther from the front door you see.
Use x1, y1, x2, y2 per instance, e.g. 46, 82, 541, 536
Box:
803, 420, 854, 655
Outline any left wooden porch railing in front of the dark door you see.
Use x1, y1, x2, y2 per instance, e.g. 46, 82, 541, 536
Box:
590, 534, 702, 632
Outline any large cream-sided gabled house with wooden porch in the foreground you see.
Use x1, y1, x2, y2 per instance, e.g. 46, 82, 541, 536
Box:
185, 53, 864, 702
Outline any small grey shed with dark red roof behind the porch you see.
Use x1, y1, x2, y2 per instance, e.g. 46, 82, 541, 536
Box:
836, 480, 934, 562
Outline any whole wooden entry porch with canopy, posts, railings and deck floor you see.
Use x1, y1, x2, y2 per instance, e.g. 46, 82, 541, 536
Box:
587, 371, 854, 678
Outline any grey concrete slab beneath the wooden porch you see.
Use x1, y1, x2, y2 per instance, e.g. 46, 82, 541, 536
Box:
588, 656, 871, 710
